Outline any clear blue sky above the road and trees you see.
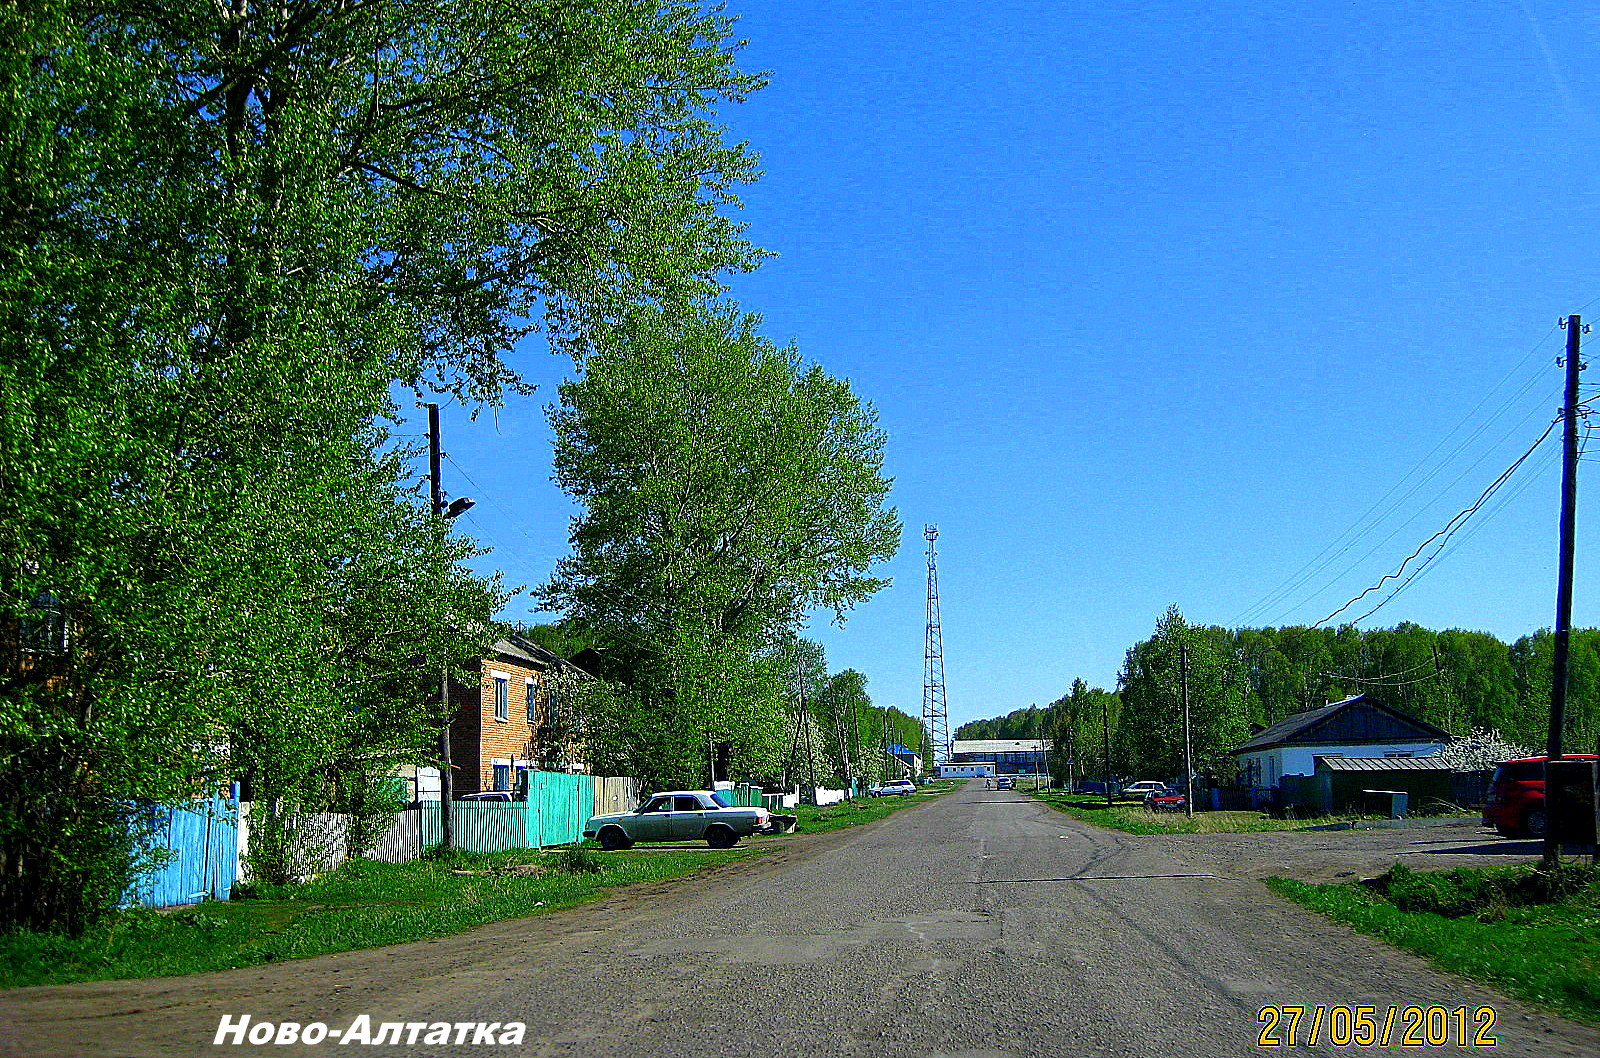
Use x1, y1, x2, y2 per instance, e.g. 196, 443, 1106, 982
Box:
406, 0, 1600, 728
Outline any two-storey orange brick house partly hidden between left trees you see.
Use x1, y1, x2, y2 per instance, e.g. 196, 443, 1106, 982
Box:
450, 634, 590, 797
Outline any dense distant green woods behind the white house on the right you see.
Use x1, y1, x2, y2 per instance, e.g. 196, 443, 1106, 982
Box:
957, 607, 1600, 783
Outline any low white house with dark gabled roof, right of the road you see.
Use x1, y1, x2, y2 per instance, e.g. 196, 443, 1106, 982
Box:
1232, 695, 1450, 787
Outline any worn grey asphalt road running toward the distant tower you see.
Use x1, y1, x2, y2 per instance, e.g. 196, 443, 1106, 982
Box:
0, 786, 1600, 1058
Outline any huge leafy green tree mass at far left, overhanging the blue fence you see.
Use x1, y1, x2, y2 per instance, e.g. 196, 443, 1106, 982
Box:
0, 0, 762, 932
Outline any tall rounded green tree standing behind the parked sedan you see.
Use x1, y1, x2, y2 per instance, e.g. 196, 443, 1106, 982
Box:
541, 300, 899, 779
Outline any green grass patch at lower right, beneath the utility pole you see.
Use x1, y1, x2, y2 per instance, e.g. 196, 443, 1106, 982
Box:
1267, 866, 1600, 1024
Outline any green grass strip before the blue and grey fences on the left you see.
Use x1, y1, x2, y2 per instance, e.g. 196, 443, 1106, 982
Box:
0, 848, 758, 988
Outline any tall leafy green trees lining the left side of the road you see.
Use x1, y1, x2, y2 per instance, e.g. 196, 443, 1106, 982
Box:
0, 0, 898, 932
